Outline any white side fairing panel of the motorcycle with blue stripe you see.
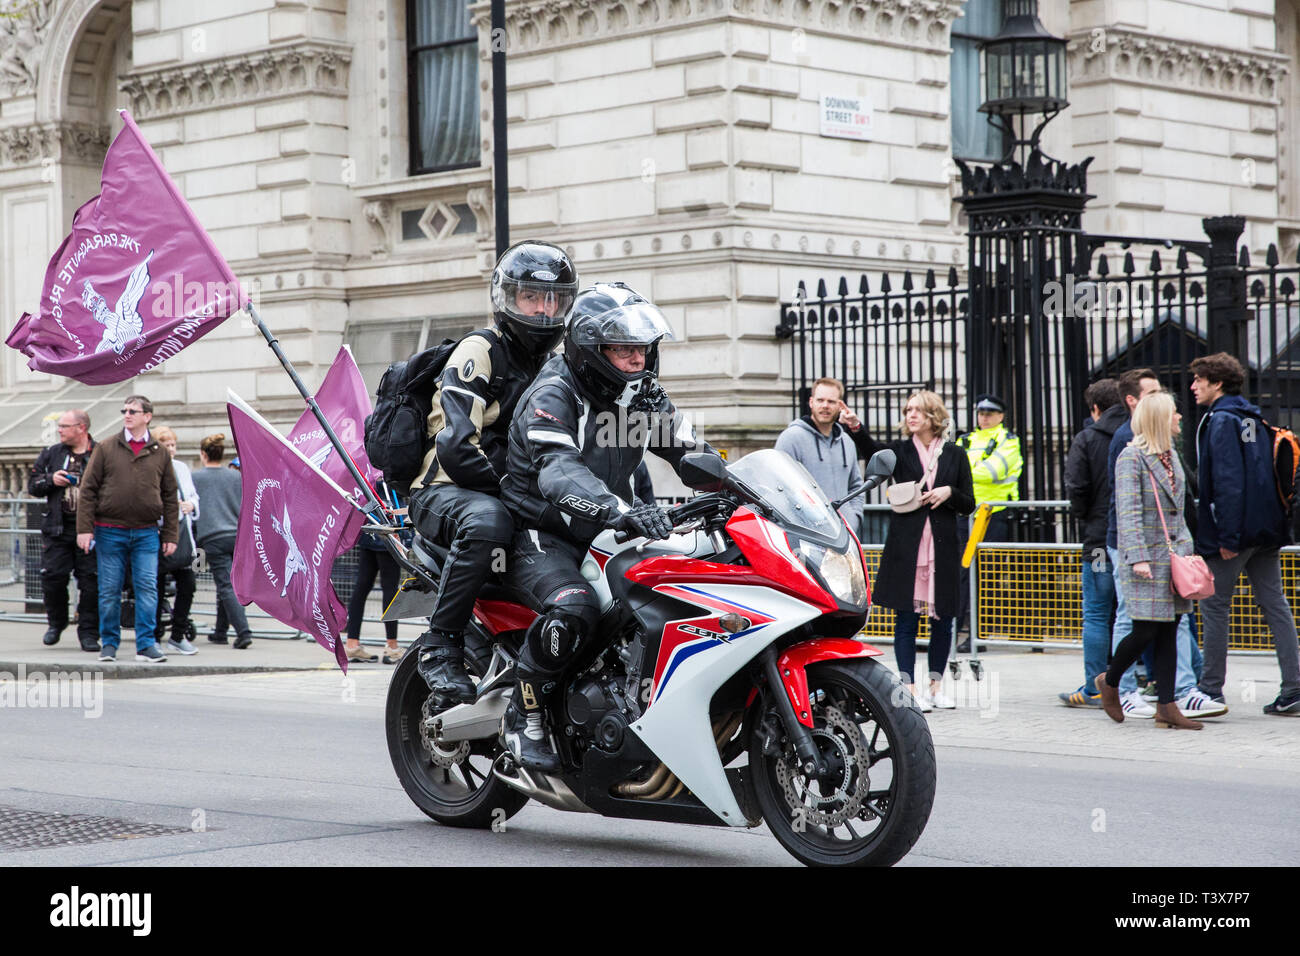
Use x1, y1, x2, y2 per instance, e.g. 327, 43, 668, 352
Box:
631, 581, 823, 826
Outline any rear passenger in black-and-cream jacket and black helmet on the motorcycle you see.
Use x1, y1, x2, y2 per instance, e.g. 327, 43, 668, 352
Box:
410, 241, 577, 706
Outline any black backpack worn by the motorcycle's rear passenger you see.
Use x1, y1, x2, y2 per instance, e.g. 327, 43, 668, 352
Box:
365, 329, 506, 494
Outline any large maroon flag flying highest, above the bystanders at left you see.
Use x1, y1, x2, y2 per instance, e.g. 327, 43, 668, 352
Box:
5, 111, 248, 385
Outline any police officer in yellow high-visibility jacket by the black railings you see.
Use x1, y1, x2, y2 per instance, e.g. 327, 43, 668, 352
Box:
957, 394, 1024, 650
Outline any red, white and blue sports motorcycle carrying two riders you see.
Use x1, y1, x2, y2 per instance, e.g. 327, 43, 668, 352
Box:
386, 449, 935, 866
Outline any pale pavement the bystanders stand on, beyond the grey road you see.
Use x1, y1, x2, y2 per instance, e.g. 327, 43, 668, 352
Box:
0, 615, 1300, 773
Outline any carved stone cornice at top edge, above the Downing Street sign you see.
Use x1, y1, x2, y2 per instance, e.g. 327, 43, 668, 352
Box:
471, 0, 965, 52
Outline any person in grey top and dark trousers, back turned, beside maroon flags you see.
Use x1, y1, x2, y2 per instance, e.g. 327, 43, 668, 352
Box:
194, 434, 252, 650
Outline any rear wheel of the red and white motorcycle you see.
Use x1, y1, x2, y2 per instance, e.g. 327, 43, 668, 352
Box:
384, 652, 528, 830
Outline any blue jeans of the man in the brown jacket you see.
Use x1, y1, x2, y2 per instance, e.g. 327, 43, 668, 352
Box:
95, 525, 159, 653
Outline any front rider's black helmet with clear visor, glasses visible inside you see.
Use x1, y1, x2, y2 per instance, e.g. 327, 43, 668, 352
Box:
564, 282, 672, 411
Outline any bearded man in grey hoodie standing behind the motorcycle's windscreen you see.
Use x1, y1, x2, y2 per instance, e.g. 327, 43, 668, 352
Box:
776, 378, 862, 535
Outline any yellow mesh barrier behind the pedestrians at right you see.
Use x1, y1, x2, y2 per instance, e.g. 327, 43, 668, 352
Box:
862, 545, 1300, 652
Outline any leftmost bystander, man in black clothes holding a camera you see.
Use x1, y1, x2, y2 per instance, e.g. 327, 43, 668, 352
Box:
27, 408, 99, 653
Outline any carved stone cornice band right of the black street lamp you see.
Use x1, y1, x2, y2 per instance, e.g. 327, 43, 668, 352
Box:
1066, 27, 1287, 100
